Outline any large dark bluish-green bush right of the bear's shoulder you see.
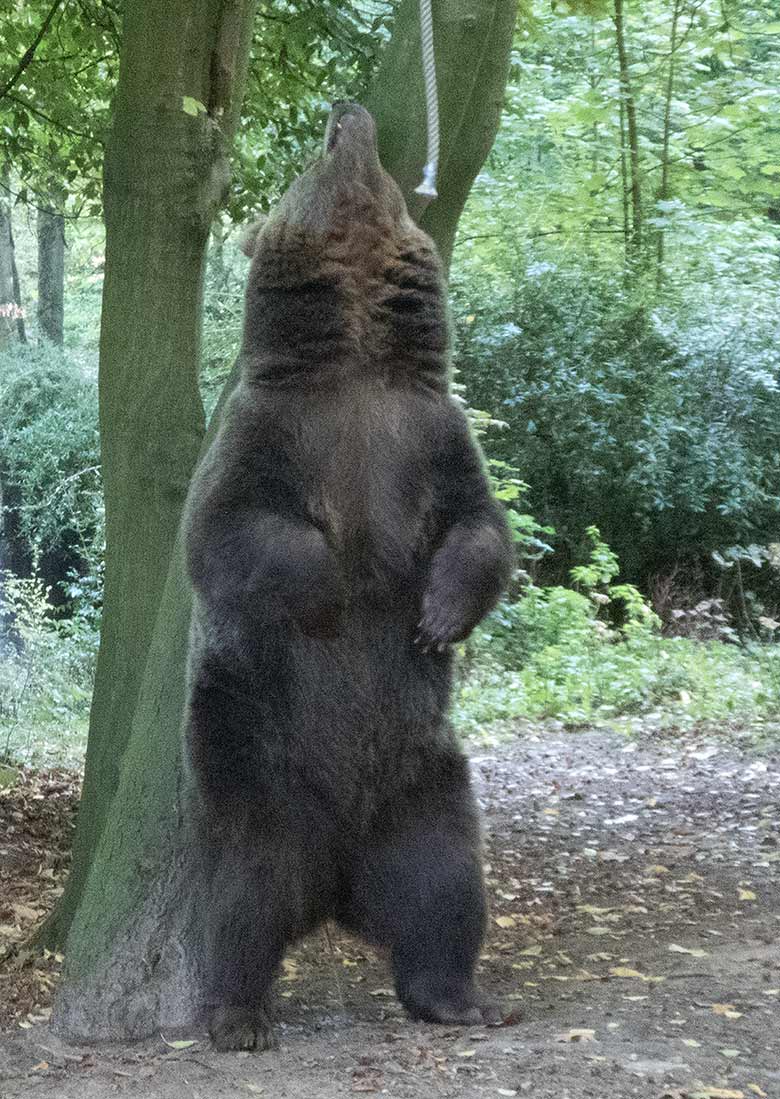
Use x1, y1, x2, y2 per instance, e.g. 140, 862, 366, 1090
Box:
454, 258, 780, 585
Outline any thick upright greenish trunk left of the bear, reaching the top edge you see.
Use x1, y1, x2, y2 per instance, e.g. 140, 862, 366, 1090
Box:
45, 0, 254, 956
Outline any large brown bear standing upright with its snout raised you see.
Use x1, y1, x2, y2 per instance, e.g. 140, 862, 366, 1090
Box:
186, 103, 513, 1050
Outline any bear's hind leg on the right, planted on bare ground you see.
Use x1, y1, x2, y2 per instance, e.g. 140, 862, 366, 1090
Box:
347, 764, 502, 1025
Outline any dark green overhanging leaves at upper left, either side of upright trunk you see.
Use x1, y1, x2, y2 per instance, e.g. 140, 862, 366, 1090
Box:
0, 0, 393, 220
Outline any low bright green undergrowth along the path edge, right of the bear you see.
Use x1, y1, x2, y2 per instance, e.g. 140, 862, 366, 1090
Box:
455, 528, 780, 733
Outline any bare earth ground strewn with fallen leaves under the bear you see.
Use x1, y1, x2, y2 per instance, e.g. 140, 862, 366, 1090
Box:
0, 731, 780, 1099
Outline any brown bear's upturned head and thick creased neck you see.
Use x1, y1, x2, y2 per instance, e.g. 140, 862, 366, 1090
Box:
243, 102, 447, 385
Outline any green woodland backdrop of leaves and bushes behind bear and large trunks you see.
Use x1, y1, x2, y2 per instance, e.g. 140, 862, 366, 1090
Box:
0, 0, 780, 764
